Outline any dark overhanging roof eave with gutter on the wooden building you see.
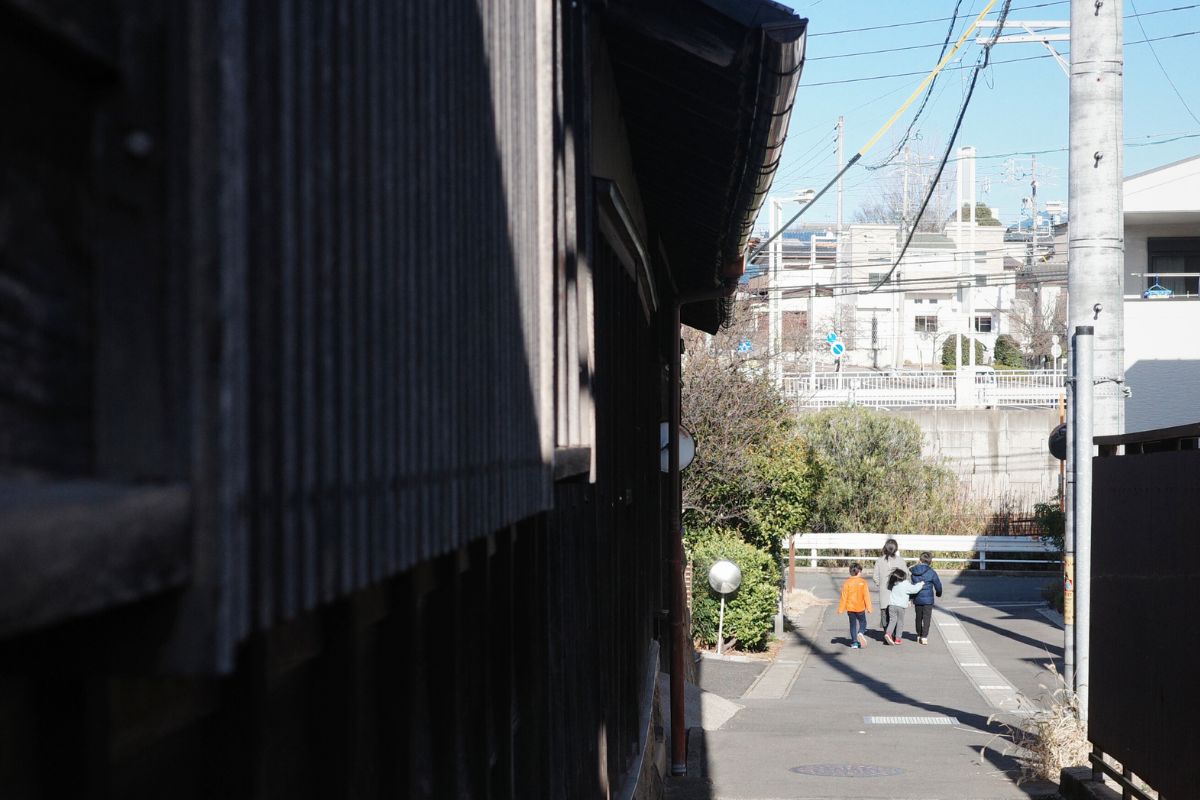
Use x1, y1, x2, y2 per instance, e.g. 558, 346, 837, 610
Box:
605, 0, 808, 332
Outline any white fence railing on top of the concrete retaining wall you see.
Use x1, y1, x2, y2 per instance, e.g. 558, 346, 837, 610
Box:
784, 368, 1067, 408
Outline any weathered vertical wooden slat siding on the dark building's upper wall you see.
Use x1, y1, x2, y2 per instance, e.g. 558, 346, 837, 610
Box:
188, 0, 554, 664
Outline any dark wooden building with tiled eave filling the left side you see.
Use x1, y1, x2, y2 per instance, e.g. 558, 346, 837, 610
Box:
0, 0, 804, 800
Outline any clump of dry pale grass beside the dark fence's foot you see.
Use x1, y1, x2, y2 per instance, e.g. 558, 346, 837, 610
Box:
985, 663, 1092, 783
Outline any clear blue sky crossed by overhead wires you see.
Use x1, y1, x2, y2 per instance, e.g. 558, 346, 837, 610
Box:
757, 0, 1200, 229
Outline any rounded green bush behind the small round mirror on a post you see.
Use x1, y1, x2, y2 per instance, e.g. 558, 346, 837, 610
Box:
688, 528, 779, 650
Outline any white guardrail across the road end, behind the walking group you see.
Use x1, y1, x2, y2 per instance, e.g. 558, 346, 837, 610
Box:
784, 534, 1062, 570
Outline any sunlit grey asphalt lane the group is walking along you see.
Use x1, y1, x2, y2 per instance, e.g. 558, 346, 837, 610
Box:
690, 573, 1061, 800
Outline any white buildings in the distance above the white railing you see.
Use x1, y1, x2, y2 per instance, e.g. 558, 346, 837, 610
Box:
761, 222, 1024, 372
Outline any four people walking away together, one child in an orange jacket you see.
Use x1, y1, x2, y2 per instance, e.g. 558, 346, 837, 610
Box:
838, 539, 942, 649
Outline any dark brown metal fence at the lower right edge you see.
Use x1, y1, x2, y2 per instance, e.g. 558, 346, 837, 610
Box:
1088, 425, 1200, 798
